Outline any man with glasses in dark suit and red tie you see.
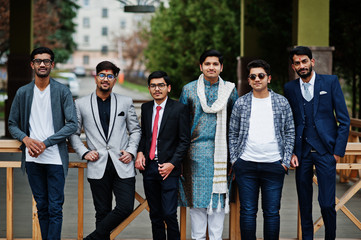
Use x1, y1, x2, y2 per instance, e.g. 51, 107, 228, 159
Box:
135, 71, 190, 240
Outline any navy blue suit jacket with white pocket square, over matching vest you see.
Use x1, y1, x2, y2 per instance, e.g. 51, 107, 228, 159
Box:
284, 74, 350, 159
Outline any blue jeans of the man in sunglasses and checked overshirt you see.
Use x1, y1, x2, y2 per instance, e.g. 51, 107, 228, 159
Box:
233, 159, 286, 240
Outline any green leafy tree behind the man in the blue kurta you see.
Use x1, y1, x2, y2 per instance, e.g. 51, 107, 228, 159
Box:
145, 0, 240, 97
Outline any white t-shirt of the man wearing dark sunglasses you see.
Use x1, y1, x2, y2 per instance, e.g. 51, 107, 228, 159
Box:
241, 95, 282, 162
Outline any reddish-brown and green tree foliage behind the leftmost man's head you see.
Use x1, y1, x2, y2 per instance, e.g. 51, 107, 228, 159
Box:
0, 0, 79, 62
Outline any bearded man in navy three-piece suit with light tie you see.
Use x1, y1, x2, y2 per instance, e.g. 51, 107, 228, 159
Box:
284, 47, 350, 239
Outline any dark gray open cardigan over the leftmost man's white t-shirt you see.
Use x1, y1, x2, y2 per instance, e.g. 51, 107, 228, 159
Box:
8, 78, 77, 176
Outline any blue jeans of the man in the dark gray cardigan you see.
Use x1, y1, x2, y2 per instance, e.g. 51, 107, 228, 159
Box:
25, 162, 65, 240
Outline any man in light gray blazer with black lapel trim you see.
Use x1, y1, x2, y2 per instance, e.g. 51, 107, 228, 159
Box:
70, 61, 141, 240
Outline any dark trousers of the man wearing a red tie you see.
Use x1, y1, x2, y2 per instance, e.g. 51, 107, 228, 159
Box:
143, 161, 180, 240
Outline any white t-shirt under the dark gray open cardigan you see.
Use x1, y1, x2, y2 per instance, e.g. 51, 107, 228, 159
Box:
25, 84, 62, 165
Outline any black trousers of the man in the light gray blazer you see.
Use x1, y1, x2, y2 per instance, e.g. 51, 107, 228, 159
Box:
88, 158, 135, 240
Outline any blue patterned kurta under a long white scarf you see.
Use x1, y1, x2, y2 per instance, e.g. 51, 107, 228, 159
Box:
179, 80, 238, 208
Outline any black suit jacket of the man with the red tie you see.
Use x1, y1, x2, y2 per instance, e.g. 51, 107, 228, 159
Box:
138, 98, 190, 176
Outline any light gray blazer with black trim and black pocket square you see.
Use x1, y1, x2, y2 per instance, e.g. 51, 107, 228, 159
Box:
70, 92, 141, 179
